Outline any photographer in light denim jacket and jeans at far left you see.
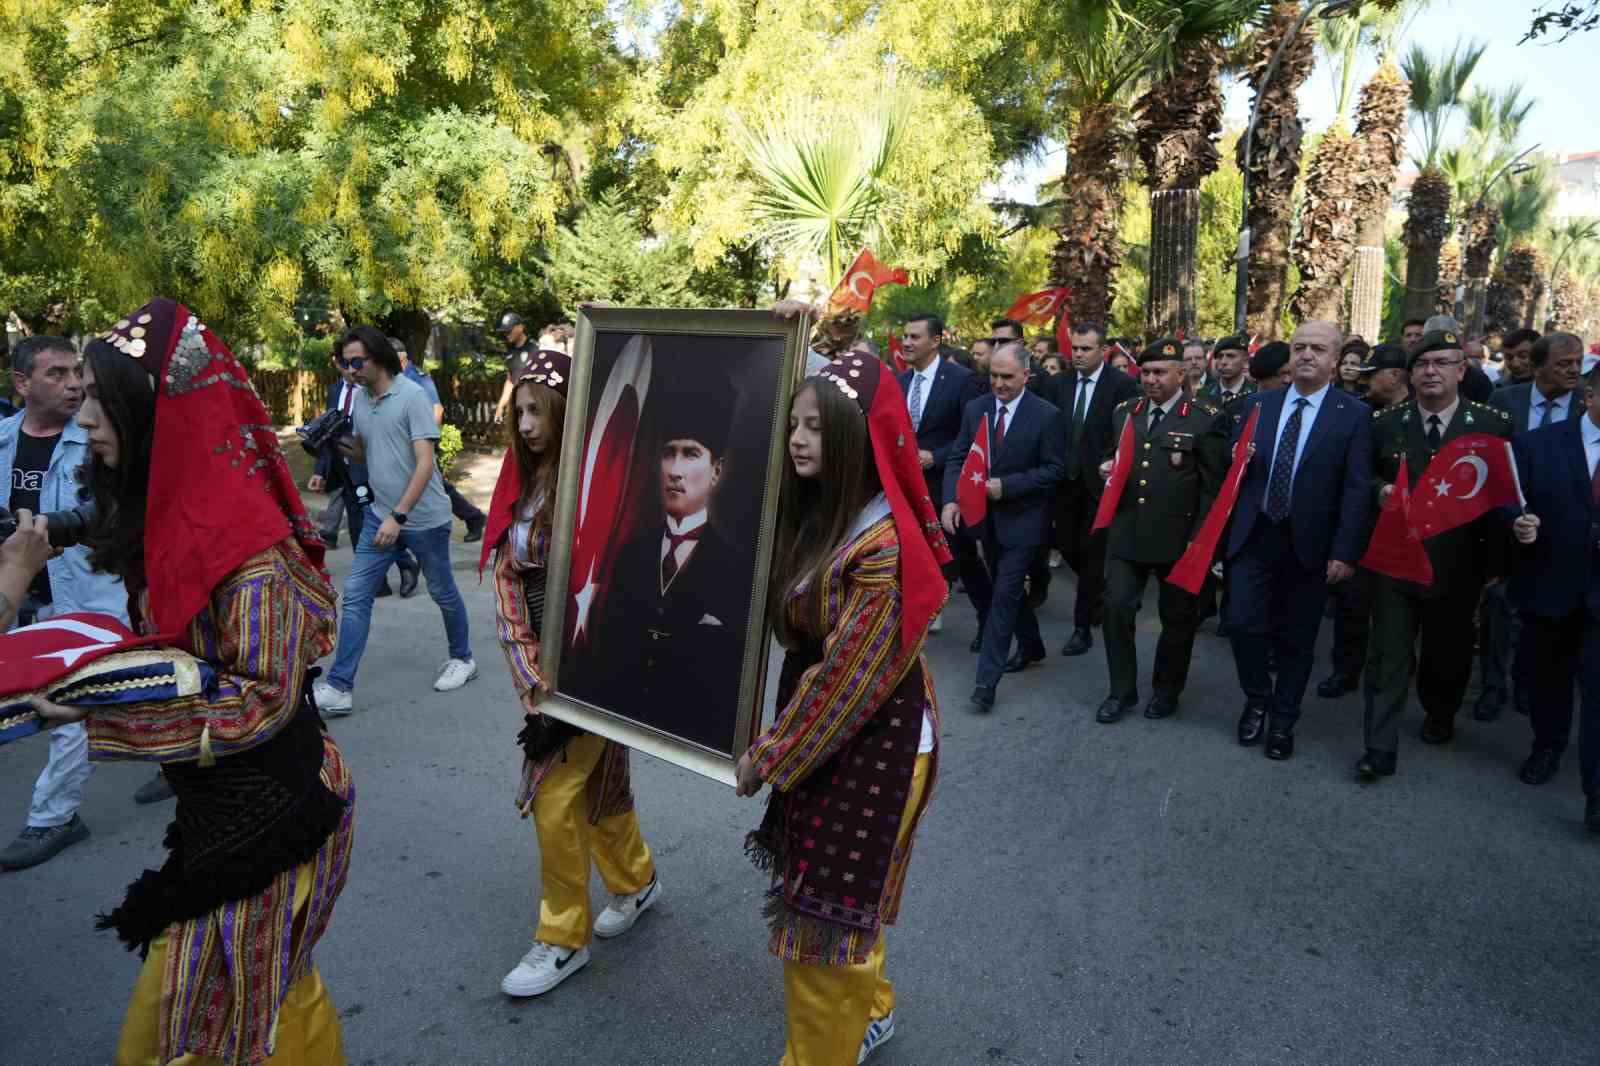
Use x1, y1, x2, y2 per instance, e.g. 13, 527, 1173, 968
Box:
0, 336, 128, 869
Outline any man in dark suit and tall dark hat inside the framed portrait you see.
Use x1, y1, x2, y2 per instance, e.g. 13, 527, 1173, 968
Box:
592, 367, 754, 754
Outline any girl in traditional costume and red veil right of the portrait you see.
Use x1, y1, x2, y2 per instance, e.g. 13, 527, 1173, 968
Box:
738, 355, 950, 1066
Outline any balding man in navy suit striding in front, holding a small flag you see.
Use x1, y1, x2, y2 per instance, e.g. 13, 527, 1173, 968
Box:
942, 344, 1066, 712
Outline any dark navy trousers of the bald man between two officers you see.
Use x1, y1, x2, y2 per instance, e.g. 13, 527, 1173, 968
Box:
1224, 515, 1328, 727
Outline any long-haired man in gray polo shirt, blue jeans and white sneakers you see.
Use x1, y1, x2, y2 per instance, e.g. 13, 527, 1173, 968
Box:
314, 325, 478, 704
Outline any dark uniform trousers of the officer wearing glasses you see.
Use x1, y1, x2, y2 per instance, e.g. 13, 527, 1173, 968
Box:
1363, 575, 1483, 751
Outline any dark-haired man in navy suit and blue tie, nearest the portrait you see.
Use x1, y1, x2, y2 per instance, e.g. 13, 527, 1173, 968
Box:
894, 314, 994, 653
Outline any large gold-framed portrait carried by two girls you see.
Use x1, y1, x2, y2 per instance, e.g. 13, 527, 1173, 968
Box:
539, 307, 810, 786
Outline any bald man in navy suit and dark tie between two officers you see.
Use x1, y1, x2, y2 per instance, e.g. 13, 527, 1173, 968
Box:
1226, 322, 1371, 759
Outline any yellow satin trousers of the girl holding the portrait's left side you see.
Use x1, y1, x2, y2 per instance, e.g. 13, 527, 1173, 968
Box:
533, 733, 656, 951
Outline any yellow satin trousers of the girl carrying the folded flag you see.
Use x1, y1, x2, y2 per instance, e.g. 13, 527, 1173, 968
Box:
117, 860, 344, 1066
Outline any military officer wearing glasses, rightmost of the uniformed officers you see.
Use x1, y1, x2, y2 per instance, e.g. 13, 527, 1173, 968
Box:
1355, 330, 1510, 781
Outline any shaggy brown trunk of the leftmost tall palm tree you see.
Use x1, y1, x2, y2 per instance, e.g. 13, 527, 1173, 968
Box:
1050, 104, 1128, 327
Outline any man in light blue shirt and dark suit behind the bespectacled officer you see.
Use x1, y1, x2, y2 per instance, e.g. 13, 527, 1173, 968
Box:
1472, 330, 1584, 722
